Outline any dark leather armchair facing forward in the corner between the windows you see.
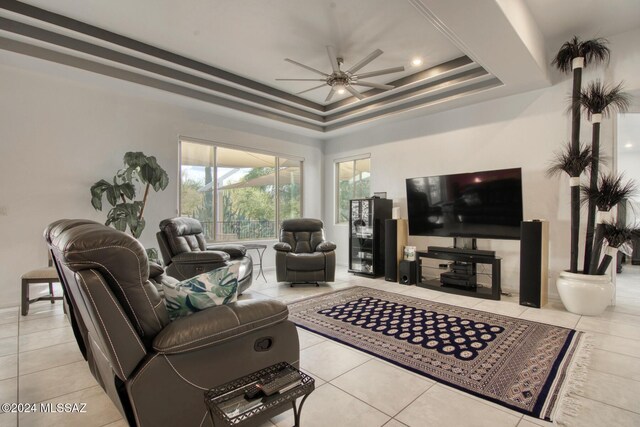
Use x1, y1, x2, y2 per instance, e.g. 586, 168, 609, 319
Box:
273, 218, 336, 284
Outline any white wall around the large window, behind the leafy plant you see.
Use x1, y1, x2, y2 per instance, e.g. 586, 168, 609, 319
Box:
0, 52, 323, 307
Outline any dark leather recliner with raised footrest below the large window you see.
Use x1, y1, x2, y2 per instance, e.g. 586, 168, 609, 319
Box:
156, 217, 253, 294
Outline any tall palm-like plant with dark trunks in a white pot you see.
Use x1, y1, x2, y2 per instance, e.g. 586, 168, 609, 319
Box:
549, 37, 633, 315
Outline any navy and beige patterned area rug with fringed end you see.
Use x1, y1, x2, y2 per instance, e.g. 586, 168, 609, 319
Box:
289, 287, 586, 421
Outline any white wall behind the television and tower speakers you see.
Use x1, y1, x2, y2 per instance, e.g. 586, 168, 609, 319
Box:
324, 31, 640, 293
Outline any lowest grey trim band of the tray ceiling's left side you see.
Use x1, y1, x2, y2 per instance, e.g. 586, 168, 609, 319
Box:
0, 37, 324, 132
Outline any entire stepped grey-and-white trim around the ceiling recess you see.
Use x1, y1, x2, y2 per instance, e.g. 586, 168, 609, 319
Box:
0, 0, 503, 132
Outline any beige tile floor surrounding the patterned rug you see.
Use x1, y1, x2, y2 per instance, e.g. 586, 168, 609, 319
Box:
0, 266, 640, 427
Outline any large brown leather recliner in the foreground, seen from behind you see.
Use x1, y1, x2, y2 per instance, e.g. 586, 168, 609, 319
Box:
45, 220, 299, 426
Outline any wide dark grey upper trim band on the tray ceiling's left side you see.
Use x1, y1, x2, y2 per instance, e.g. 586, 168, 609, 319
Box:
0, 1, 324, 111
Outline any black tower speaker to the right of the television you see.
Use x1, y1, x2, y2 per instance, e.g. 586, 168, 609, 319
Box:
520, 220, 549, 308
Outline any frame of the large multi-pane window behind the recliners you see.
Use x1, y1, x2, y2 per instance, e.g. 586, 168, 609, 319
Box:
176, 139, 305, 243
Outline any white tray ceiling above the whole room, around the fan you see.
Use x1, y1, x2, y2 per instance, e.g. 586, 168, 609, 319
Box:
0, 0, 640, 132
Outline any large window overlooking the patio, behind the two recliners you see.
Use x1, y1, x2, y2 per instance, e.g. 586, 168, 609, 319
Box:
180, 140, 302, 241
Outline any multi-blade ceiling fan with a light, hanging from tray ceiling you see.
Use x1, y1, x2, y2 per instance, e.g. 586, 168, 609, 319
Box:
276, 46, 404, 102
